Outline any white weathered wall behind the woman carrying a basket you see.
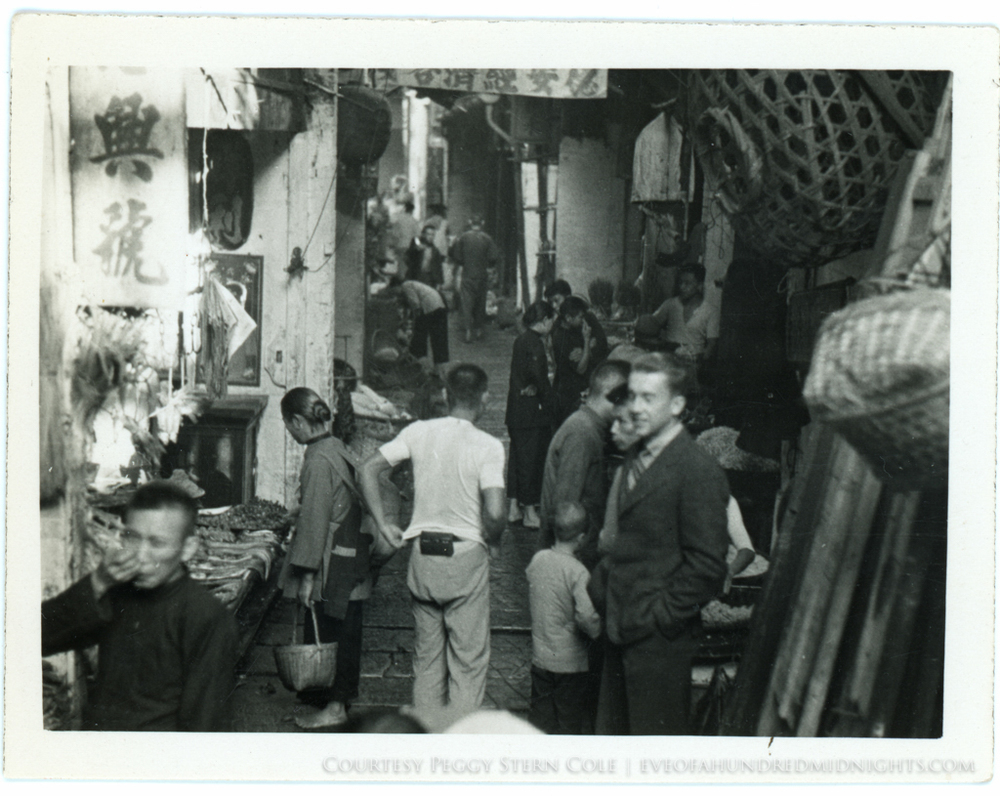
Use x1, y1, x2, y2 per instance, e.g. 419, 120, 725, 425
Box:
230, 102, 337, 505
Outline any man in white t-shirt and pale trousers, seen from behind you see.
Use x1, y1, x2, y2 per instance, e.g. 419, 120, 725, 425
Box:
361, 364, 505, 716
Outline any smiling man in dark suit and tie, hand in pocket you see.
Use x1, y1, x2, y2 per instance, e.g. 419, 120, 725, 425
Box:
590, 353, 729, 735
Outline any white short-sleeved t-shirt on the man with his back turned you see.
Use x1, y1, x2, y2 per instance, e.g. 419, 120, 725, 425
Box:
379, 417, 504, 543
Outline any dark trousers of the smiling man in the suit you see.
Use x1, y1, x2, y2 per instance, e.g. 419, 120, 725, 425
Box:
597, 630, 698, 735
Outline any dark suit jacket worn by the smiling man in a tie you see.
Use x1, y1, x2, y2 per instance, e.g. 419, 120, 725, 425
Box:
595, 430, 729, 644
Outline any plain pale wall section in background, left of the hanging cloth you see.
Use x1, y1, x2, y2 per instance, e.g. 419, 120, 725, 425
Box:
556, 138, 625, 296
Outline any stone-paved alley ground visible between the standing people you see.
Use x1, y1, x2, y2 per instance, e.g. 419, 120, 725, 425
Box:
236, 314, 536, 732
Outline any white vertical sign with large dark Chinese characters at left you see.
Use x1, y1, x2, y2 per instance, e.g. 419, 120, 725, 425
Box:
69, 67, 188, 309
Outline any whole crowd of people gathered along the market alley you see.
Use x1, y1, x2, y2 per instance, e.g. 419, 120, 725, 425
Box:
42, 233, 753, 734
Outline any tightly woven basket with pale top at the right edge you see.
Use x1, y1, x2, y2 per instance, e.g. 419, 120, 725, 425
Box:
803, 288, 951, 488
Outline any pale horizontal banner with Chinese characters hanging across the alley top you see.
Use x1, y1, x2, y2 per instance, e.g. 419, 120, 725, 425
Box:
375, 69, 608, 99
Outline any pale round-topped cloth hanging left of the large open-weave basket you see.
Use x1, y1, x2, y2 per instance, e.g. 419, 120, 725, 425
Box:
632, 112, 687, 202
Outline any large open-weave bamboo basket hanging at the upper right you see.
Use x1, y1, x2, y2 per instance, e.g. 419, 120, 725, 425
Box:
694, 69, 942, 266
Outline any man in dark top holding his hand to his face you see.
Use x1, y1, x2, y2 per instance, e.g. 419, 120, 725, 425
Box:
42, 481, 236, 732
